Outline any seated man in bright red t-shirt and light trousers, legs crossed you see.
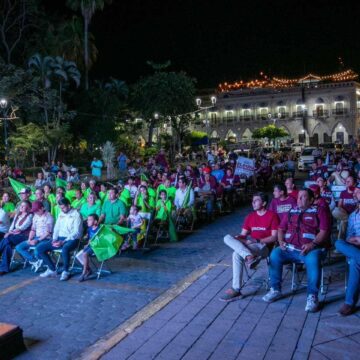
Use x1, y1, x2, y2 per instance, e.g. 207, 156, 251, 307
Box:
220, 192, 279, 301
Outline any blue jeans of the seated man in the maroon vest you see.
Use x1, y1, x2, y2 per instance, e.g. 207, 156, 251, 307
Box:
270, 247, 326, 296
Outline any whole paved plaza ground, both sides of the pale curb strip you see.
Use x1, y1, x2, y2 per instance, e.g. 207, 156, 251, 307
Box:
0, 204, 360, 360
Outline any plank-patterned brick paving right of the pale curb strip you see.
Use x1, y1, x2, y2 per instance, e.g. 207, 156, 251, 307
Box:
102, 256, 360, 360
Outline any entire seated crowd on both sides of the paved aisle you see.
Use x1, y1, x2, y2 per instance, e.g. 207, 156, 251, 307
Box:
0, 146, 360, 315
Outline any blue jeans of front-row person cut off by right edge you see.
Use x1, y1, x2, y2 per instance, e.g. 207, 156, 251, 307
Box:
335, 240, 360, 306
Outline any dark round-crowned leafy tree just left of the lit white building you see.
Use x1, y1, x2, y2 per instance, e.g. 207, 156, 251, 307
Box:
132, 63, 195, 153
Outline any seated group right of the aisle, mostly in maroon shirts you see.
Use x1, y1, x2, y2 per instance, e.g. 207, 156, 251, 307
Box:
221, 148, 360, 316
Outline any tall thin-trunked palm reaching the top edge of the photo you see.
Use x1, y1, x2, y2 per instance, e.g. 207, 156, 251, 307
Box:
67, 0, 112, 90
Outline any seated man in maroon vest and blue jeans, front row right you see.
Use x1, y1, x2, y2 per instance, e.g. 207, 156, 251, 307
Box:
263, 189, 331, 312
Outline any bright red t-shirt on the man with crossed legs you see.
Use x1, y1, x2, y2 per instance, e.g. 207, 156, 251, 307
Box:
243, 210, 279, 240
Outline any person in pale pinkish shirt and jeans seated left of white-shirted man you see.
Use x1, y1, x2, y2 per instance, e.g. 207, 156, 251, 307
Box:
16, 201, 54, 272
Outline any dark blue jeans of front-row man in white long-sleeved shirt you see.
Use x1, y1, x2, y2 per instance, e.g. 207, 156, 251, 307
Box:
36, 237, 79, 271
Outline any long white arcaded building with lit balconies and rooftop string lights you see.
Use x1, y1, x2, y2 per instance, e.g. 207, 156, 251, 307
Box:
195, 75, 360, 146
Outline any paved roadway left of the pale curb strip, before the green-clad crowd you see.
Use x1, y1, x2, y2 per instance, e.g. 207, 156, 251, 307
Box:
0, 205, 248, 359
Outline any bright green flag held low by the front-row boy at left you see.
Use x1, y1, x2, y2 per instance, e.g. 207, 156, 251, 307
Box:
90, 225, 131, 261
